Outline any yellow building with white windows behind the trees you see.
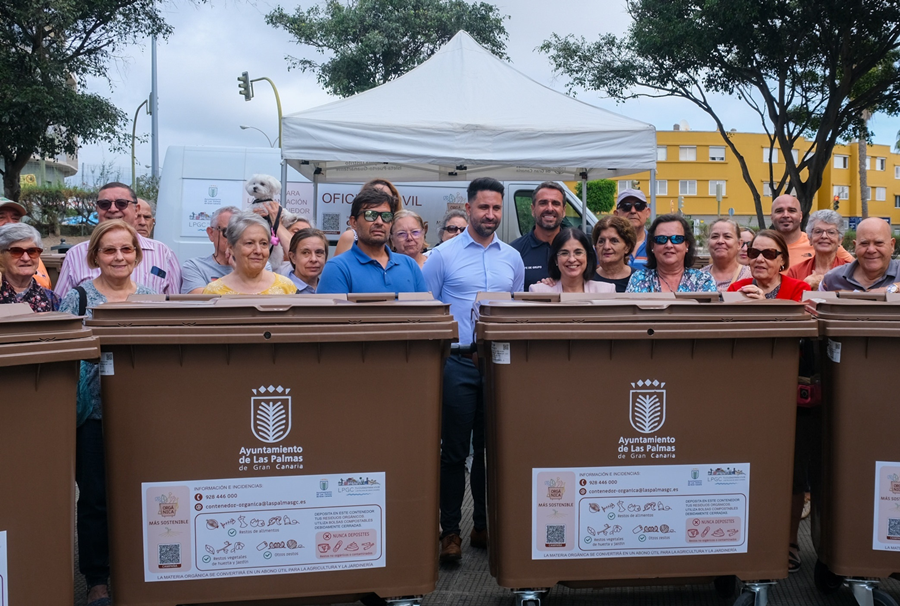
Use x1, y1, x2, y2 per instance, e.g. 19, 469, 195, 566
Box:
618, 130, 900, 226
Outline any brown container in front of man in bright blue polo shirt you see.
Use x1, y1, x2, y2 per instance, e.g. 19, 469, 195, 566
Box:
90, 296, 456, 606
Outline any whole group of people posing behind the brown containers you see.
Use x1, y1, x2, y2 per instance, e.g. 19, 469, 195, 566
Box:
0, 178, 900, 606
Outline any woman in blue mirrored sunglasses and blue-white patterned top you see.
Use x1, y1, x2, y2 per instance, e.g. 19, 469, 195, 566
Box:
625, 215, 716, 293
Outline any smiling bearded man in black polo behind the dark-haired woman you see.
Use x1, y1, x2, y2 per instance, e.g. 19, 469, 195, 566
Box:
510, 181, 566, 292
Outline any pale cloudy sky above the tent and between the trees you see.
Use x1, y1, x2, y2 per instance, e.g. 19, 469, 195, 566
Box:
76, 0, 900, 179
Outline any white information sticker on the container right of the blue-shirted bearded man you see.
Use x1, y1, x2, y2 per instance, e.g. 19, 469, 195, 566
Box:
531, 463, 750, 560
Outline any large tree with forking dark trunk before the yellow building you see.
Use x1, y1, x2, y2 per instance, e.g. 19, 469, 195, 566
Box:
541, 0, 900, 226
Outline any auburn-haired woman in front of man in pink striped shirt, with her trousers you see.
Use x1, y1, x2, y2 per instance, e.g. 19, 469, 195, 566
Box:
59, 219, 155, 604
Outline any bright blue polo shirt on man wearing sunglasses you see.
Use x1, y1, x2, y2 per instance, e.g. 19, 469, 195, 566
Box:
316, 242, 428, 294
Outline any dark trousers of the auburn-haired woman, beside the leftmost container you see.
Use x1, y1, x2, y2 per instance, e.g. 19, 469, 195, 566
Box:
75, 419, 109, 588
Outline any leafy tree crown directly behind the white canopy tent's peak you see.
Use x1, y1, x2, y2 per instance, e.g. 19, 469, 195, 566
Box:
266, 0, 507, 97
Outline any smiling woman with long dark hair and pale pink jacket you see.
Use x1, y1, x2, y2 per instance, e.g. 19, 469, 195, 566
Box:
528, 227, 616, 293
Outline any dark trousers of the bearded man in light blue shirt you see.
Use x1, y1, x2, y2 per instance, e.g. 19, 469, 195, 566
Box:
441, 356, 487, 536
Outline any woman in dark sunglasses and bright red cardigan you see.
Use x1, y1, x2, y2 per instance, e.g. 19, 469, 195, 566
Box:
728, 229, 810, 301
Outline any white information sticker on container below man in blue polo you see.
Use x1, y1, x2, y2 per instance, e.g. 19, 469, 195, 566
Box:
141, 472, 385, 582
